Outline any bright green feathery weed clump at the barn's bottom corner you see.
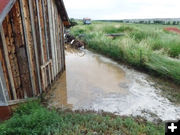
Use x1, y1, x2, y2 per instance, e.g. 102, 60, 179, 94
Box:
0, 101, 62, 135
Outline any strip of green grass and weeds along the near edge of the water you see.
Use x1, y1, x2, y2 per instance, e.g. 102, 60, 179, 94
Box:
0, 101, 165, 135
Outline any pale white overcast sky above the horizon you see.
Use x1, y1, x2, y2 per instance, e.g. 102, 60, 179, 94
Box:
64, 0, 180, 19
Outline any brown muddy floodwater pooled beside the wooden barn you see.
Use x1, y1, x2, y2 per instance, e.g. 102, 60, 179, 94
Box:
49, 48, 180, 120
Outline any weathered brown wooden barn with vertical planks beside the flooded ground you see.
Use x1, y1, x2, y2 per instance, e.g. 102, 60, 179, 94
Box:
0, 0, 69, 119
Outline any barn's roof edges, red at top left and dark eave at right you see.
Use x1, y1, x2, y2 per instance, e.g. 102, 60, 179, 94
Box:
0, 0, 70, 26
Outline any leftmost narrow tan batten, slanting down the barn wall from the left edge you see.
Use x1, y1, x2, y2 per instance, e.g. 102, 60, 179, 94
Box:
1, 25, 17, 99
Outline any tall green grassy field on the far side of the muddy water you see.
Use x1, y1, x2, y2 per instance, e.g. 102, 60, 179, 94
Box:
71, 22, 180, 84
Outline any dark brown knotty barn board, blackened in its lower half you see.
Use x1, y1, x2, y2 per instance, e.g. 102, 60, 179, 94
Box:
10, 1, 32, 98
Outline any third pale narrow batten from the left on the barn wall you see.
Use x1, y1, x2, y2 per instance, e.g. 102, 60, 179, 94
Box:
28, 0, 42, 93
